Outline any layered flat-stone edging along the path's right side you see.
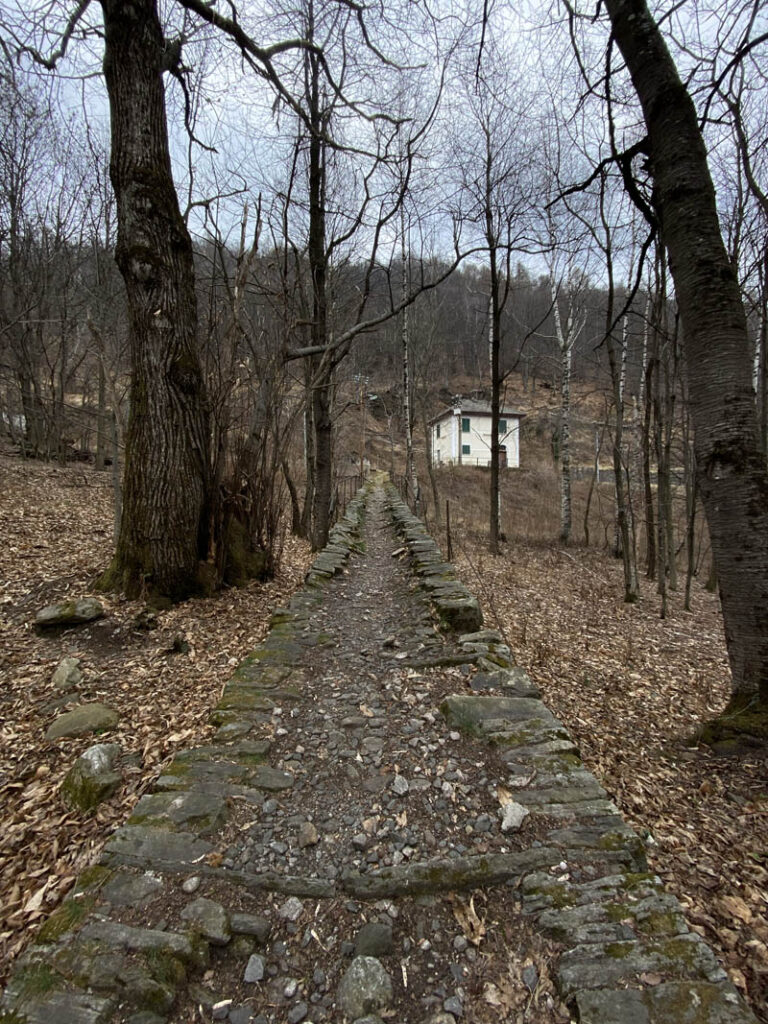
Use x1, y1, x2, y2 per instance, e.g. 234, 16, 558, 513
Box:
387, 486, 756, 1024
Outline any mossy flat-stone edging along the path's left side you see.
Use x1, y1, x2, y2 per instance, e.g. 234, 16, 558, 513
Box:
0, 487, 368, 1024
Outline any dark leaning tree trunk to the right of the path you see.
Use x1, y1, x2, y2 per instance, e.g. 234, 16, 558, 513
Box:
606, 0, 768, 706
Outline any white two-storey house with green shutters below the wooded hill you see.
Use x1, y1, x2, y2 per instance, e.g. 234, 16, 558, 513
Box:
430, 398, 525, 469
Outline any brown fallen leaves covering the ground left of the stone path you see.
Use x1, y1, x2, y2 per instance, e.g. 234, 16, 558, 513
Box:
0, 457, 309, 983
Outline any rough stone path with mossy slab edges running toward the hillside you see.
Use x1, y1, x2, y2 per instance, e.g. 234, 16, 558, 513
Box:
0, 486, 755, 1024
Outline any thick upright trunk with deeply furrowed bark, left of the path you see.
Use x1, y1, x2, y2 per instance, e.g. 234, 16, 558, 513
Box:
101, 0, 214, 600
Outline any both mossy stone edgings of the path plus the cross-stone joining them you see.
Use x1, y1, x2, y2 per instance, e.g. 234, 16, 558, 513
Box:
0, 487, 756, 1024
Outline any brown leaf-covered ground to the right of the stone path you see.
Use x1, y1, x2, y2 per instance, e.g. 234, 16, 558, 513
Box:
454, 535, 768, 1021
